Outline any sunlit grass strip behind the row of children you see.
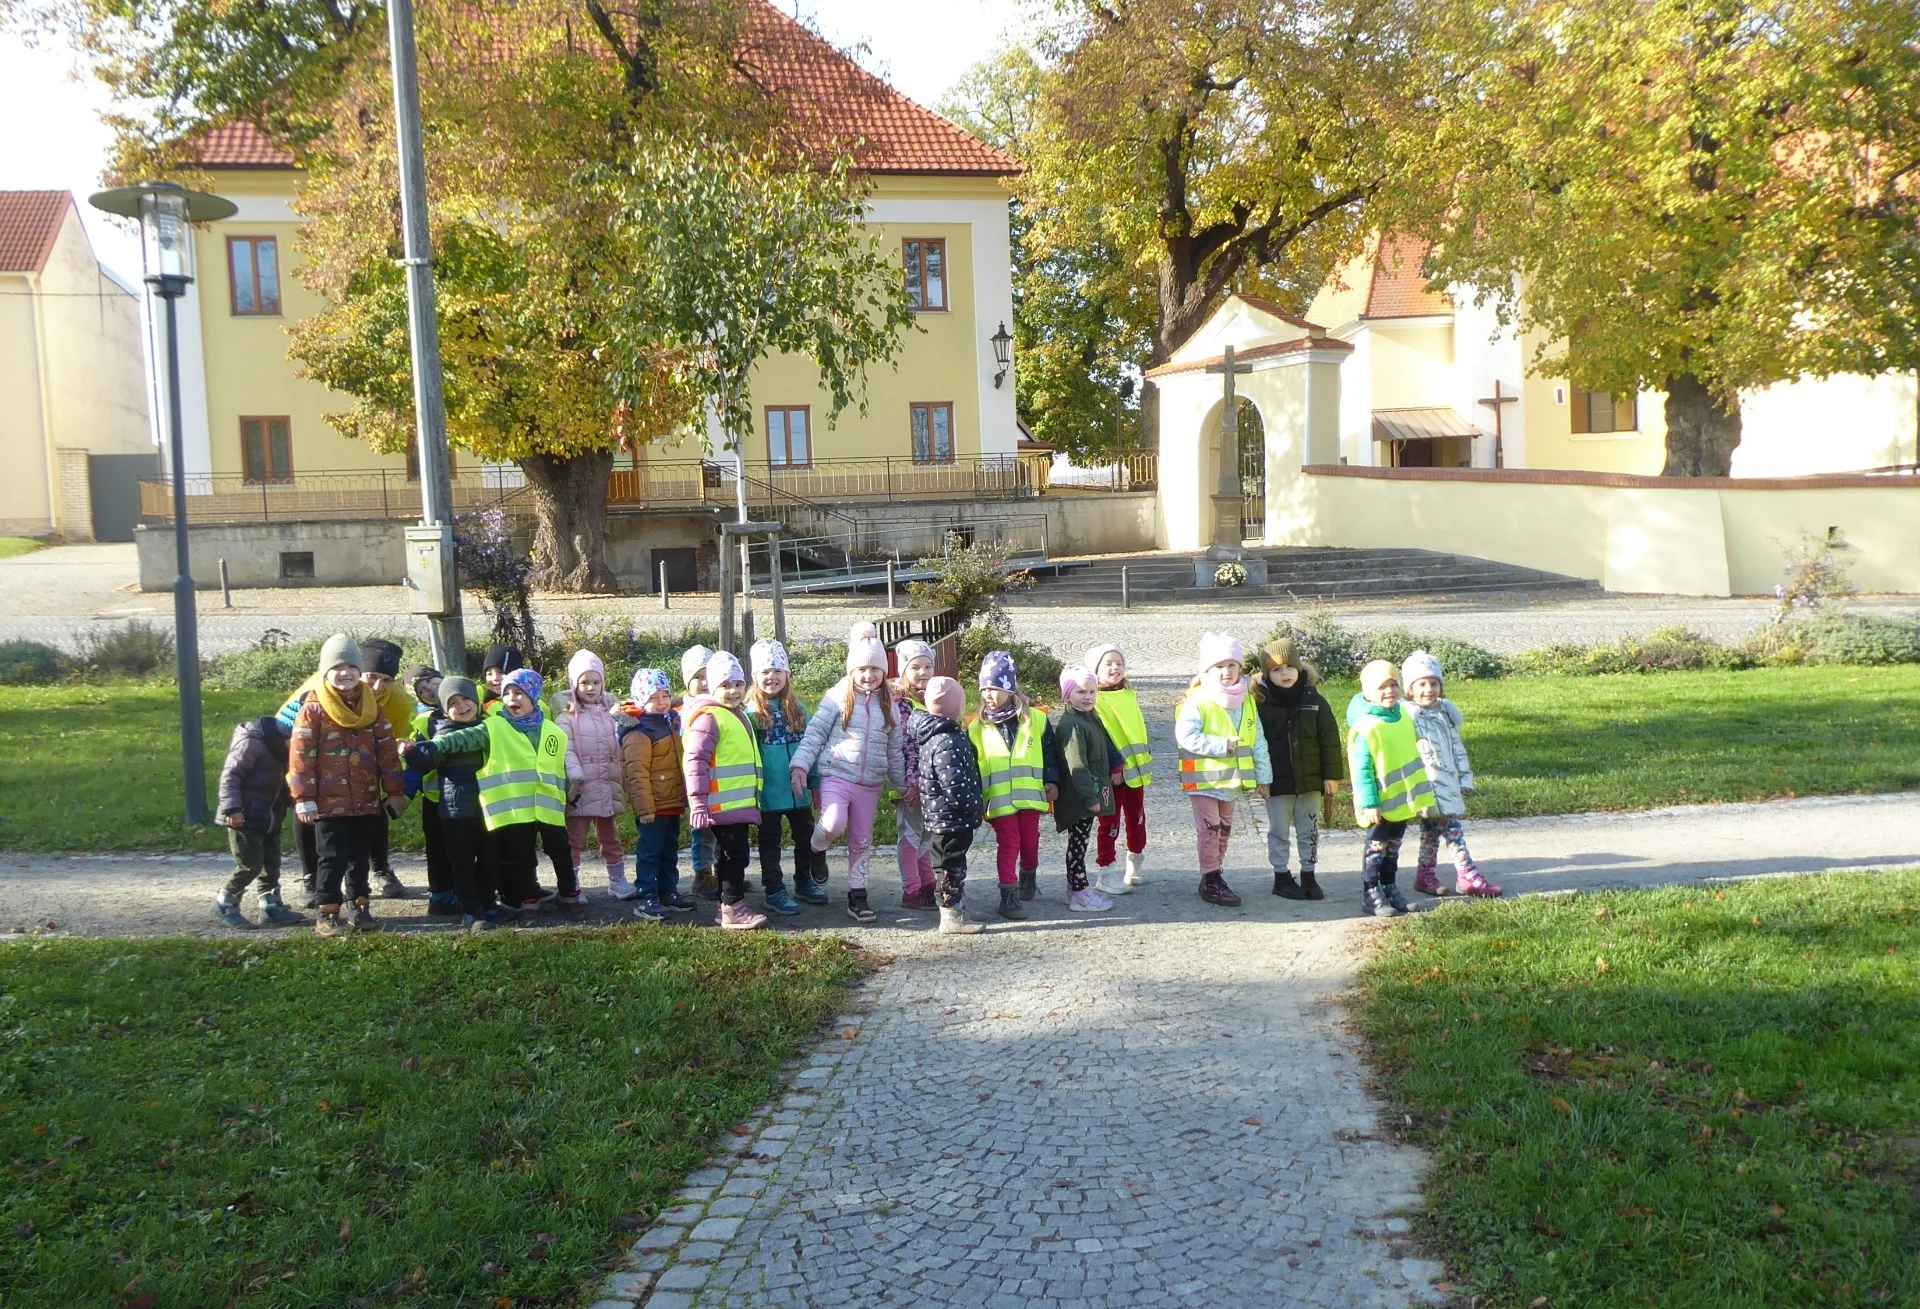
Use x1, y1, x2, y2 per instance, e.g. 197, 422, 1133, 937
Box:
0, 666, 1920, 850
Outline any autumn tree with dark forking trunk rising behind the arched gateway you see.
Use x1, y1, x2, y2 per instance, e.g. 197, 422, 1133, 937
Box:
1020, 0, 1425, 443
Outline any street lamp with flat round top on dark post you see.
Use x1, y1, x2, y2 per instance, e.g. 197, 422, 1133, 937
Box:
88, 182, 234, 825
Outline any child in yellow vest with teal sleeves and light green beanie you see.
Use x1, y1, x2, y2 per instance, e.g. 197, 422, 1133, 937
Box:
1346, 658, 1432, 917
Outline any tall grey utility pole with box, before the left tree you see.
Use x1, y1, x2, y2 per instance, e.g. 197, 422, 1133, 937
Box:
386, 0, 467, 674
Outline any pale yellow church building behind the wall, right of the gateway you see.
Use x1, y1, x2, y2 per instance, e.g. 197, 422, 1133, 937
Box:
1306, 236, 1920, 478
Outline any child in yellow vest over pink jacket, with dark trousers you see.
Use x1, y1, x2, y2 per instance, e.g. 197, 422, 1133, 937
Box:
680, 651, 766, 931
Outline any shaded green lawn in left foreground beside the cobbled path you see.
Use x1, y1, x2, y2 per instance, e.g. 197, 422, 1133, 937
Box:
0, 927, 864, 1307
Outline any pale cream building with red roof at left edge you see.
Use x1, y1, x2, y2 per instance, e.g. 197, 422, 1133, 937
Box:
0, 190, 159, 541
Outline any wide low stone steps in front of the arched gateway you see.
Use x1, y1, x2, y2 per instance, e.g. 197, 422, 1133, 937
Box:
1010, 547, 1599, 605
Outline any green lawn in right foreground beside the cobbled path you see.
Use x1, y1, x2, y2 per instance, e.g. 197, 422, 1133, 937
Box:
1361, 867, 1920, 1309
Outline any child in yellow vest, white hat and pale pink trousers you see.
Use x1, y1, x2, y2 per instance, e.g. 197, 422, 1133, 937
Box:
1173, 631, 1273, 908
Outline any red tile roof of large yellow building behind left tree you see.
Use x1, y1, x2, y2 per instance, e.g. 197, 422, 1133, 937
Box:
200, 0, 1020, 177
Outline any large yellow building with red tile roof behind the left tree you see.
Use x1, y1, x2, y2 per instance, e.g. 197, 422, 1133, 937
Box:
180, 4, 1020, 499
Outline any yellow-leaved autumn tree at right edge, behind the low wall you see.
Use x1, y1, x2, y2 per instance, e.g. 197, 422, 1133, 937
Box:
1413, 0, 1920, 476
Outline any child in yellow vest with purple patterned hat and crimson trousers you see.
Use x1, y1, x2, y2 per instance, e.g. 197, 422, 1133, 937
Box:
968, 651, 1060, 921
